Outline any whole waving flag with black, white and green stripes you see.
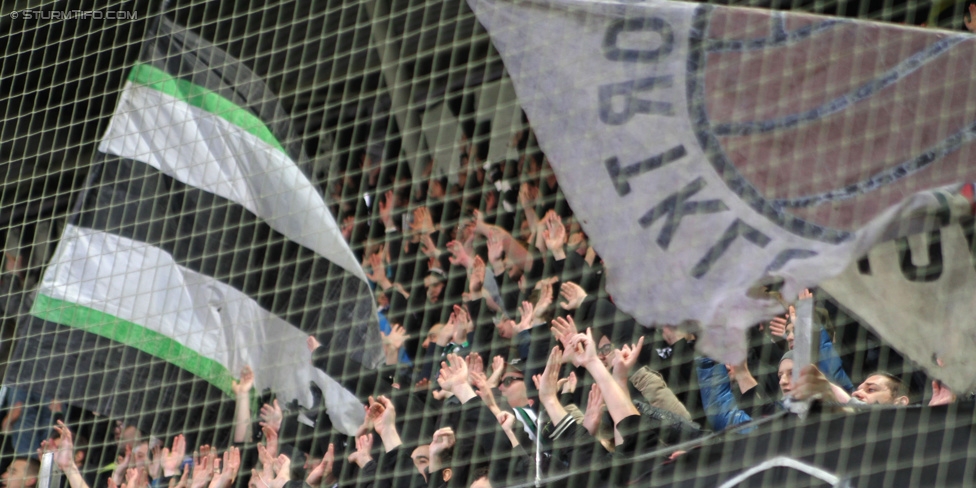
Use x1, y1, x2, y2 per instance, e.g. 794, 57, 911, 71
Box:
7, 18, 383, 432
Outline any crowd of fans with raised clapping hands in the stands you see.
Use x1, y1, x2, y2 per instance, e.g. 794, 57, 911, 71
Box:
2, 127, 955, 488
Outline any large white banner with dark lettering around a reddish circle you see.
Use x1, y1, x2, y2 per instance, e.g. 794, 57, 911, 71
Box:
469, 0, 976, 388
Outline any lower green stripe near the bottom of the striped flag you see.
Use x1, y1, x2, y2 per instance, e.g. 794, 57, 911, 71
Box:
31, 293, 234, 395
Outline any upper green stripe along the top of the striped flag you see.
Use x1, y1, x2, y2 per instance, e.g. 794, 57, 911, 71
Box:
129, 63, 288, 154
